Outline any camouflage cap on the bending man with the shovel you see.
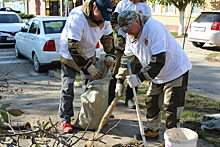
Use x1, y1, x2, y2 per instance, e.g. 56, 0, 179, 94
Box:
118, 11, 139, 33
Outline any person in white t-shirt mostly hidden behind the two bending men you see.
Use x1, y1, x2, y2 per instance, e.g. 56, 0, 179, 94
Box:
109, 0, 151, 109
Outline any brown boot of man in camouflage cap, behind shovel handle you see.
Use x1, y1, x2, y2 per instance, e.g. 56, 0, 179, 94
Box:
134, 129, 159, 140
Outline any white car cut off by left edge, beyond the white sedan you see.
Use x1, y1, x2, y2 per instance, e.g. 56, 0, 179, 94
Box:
0, 12, 25, 45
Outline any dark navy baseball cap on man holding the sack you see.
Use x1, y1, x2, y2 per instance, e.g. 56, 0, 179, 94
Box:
96, 0, 113, 21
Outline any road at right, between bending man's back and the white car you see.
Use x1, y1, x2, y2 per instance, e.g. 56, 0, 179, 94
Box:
177, 39, 220, 101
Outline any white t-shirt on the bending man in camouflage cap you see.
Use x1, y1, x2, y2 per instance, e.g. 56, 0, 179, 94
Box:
124, 17, 192, 84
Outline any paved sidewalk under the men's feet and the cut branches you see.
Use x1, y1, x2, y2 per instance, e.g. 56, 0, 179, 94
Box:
0, 70, 215, 147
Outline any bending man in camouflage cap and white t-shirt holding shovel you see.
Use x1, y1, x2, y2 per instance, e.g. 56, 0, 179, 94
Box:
116, 11, 192, 139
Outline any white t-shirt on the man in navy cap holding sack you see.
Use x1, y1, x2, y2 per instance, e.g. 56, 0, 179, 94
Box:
60, 6, 112, 59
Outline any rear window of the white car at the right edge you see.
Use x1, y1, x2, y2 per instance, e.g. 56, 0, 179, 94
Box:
195, 13, 220, 22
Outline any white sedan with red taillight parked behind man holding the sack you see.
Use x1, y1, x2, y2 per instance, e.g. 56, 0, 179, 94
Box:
15, 16, 66, 72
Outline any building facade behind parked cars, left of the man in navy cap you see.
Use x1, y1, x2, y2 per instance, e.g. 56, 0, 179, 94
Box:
0, 0, 83, 16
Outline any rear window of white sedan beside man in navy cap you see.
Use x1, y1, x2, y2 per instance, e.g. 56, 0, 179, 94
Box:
43, 20, 66, 34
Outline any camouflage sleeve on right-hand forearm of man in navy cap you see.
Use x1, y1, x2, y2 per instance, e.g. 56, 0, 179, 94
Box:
100, 33, 115, 59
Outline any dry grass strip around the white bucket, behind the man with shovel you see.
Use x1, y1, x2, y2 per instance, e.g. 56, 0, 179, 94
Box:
138, 82, 220, 147
